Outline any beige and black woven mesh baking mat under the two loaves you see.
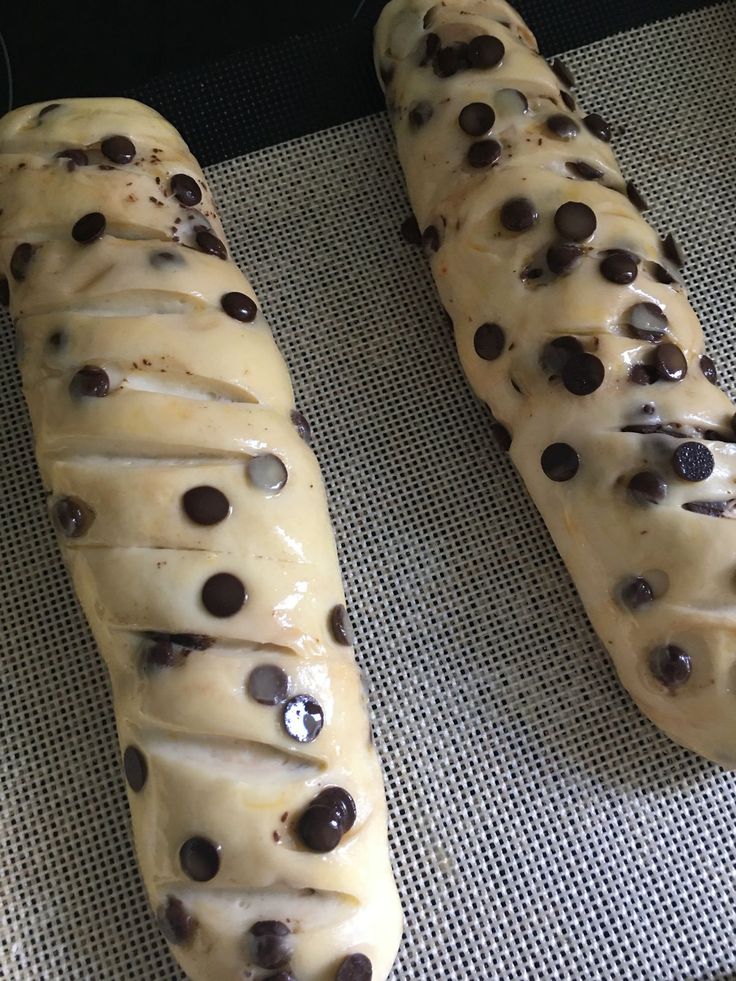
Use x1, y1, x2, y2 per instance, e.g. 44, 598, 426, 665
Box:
0, 5, 736, 981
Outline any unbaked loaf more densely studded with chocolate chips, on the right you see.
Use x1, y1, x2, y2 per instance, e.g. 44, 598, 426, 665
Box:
376, 0, 736, 767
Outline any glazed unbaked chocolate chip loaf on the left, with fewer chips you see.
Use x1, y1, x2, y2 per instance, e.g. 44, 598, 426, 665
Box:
0, 99, 401, 981
